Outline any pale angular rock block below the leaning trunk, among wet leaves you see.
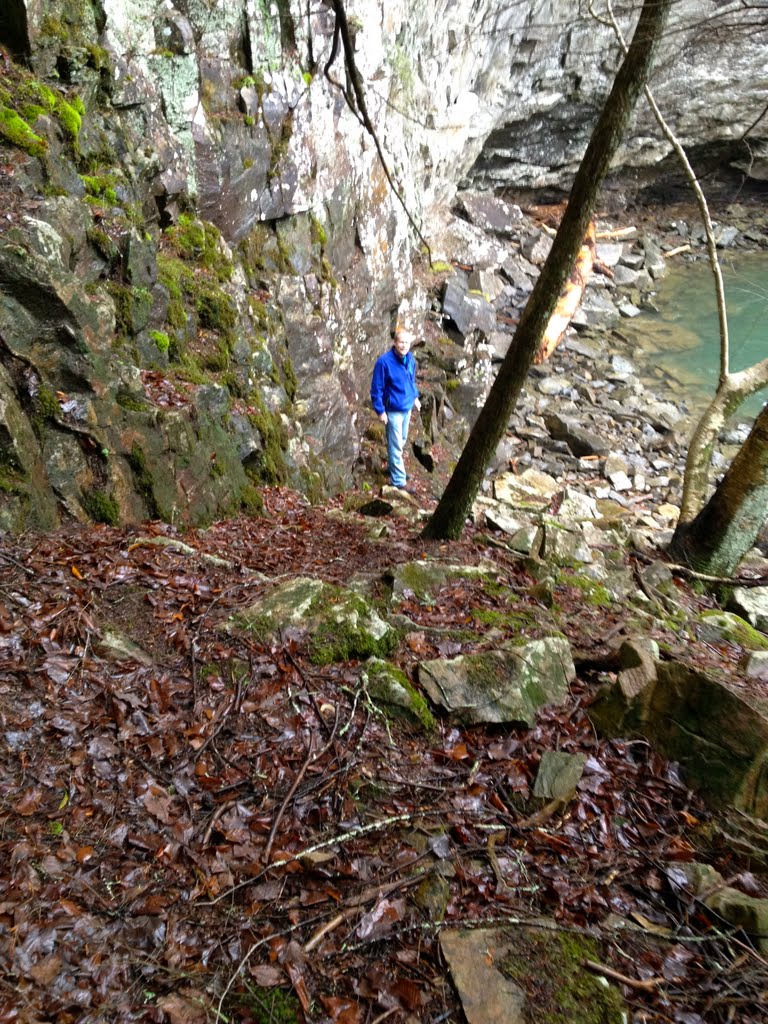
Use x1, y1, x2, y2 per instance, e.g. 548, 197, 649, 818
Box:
419, 637, 575, 727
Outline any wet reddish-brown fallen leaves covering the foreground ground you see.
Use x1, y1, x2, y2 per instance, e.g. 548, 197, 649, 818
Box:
0, 489, 768, 1024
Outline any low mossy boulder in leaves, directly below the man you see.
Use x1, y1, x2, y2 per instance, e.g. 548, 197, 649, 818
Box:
228, 577, 398, 665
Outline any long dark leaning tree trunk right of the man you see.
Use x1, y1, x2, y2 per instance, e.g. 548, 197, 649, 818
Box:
422, 0, 672, 540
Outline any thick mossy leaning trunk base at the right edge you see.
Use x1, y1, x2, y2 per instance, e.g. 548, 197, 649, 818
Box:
670, 406, 768, 577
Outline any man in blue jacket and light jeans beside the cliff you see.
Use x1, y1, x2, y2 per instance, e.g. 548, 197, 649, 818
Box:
371, 324, 421, 490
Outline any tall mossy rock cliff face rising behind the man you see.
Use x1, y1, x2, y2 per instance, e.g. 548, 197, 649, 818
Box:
0, 0, 766, 528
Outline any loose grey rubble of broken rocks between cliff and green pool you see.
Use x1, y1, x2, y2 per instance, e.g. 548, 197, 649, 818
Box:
417, 191, 756, 540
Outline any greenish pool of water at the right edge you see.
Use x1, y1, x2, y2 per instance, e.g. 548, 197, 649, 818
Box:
622, 253, 768, 419
